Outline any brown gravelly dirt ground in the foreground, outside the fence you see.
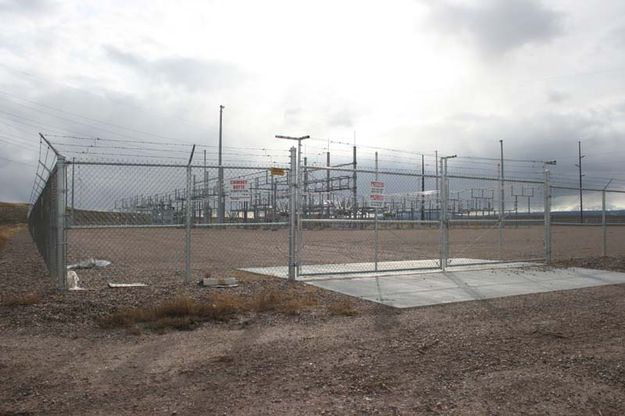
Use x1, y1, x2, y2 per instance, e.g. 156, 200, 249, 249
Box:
0, 231, 625, 415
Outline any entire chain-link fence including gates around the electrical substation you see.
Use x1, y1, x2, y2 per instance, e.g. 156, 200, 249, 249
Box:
29, 138, 625, 288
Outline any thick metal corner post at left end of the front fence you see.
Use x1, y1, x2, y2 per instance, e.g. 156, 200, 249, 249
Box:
55, 155, 67, 290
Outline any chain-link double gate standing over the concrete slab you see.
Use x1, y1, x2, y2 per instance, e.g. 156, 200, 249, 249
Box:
295, 154, 550, 276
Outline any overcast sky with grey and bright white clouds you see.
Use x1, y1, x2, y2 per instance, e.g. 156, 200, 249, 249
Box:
0, 0, 625, 205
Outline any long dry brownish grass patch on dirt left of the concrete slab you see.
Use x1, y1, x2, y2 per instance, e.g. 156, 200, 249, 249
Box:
100, 289, 318, 332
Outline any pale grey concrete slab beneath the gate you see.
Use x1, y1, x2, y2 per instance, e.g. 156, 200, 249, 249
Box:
244, 259, 625, 308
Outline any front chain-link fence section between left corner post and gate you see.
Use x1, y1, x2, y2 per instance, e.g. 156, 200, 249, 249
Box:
61, 162, 289, 283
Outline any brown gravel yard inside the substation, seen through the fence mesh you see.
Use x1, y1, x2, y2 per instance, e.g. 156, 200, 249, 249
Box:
68, 224, 625, 283
